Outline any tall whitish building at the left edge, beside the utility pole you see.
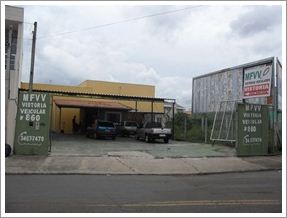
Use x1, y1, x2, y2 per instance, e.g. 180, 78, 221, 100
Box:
5, 5, 24, 152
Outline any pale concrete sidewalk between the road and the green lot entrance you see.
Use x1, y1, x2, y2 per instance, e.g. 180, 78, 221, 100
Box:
6, 152, 282, 175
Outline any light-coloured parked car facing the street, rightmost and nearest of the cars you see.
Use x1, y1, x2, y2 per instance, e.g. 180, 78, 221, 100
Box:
136, 122, 171, 143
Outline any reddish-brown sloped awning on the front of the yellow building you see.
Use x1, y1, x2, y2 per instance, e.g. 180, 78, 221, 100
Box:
54, 99, 132, 110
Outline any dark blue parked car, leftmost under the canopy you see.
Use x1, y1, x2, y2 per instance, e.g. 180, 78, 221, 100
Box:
87, 120, 116, 140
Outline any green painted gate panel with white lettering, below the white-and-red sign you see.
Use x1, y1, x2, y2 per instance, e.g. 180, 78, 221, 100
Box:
236, 104, 268, 156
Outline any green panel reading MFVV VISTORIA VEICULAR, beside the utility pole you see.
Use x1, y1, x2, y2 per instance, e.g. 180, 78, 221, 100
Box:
15, 92, 50, 155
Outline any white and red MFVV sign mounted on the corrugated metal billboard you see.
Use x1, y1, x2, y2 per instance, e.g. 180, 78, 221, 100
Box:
243, 64, 272, 98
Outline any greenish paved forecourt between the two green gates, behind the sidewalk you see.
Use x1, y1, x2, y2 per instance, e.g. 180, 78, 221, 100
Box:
51, 134, 236, 158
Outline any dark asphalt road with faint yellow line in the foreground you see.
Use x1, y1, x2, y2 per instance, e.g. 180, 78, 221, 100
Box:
6, 171, 281, 213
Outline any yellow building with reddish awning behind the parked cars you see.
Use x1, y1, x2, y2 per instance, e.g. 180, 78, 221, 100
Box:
21, 80, 164, 134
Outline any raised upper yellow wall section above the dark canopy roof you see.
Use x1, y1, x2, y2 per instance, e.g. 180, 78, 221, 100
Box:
80, 80, 155, 97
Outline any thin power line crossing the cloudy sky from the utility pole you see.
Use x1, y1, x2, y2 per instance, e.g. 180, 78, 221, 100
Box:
38, 5, 206, 39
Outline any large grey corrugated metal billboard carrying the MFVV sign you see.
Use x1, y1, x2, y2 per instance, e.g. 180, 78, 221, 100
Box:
192, 57, 282, 114
